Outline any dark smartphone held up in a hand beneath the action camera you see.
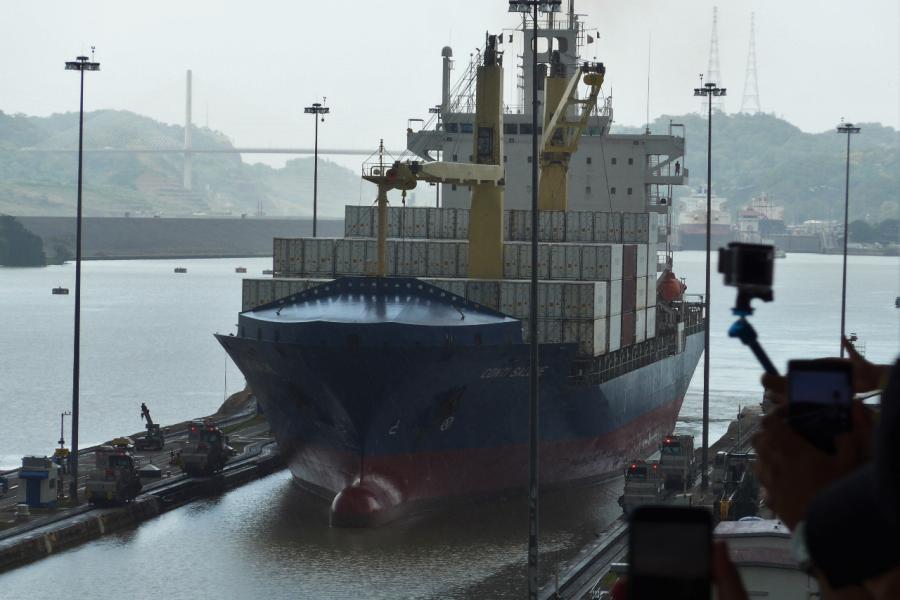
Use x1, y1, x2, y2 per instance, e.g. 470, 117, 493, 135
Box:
788, 360, 853, 454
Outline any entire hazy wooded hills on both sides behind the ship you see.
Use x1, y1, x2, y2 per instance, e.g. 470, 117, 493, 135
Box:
0, 110, 900, 222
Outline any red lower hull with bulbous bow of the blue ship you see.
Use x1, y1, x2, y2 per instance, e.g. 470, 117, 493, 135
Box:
289, 398, 683, 527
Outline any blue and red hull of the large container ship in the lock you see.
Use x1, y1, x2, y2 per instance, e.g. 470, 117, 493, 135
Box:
217, 333, 703, 526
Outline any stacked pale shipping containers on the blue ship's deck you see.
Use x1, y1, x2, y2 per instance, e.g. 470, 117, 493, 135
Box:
260, 206, 659, 356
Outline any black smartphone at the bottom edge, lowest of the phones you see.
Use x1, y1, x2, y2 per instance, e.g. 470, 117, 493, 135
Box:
628, 506, 712, 600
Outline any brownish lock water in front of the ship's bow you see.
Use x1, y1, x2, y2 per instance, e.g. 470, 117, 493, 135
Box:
0, 472, 621, 600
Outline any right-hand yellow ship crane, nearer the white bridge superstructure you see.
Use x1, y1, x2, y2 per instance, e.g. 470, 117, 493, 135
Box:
538, 51, 606, 210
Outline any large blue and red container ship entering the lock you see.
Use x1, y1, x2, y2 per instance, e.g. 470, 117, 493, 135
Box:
217, 2, 703, 526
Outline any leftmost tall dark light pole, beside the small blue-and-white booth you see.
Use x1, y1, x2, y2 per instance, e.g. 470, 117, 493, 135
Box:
66, 48, 100, 501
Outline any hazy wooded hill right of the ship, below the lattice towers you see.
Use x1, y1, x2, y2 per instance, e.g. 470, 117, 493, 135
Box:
613, 112, 900, 222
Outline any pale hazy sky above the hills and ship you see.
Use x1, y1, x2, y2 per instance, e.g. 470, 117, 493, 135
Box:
0, 0, 900, 169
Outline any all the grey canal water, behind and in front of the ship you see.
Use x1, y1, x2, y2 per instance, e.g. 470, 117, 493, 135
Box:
0, 252, 900, 599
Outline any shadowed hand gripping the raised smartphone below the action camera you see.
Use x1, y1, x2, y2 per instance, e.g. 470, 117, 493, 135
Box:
752, 404, 871, 529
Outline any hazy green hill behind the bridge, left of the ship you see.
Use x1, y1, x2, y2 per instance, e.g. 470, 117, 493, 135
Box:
0, 110, 360, 217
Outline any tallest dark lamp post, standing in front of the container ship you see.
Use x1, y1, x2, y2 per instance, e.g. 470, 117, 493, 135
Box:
509, 0, 562, 599
